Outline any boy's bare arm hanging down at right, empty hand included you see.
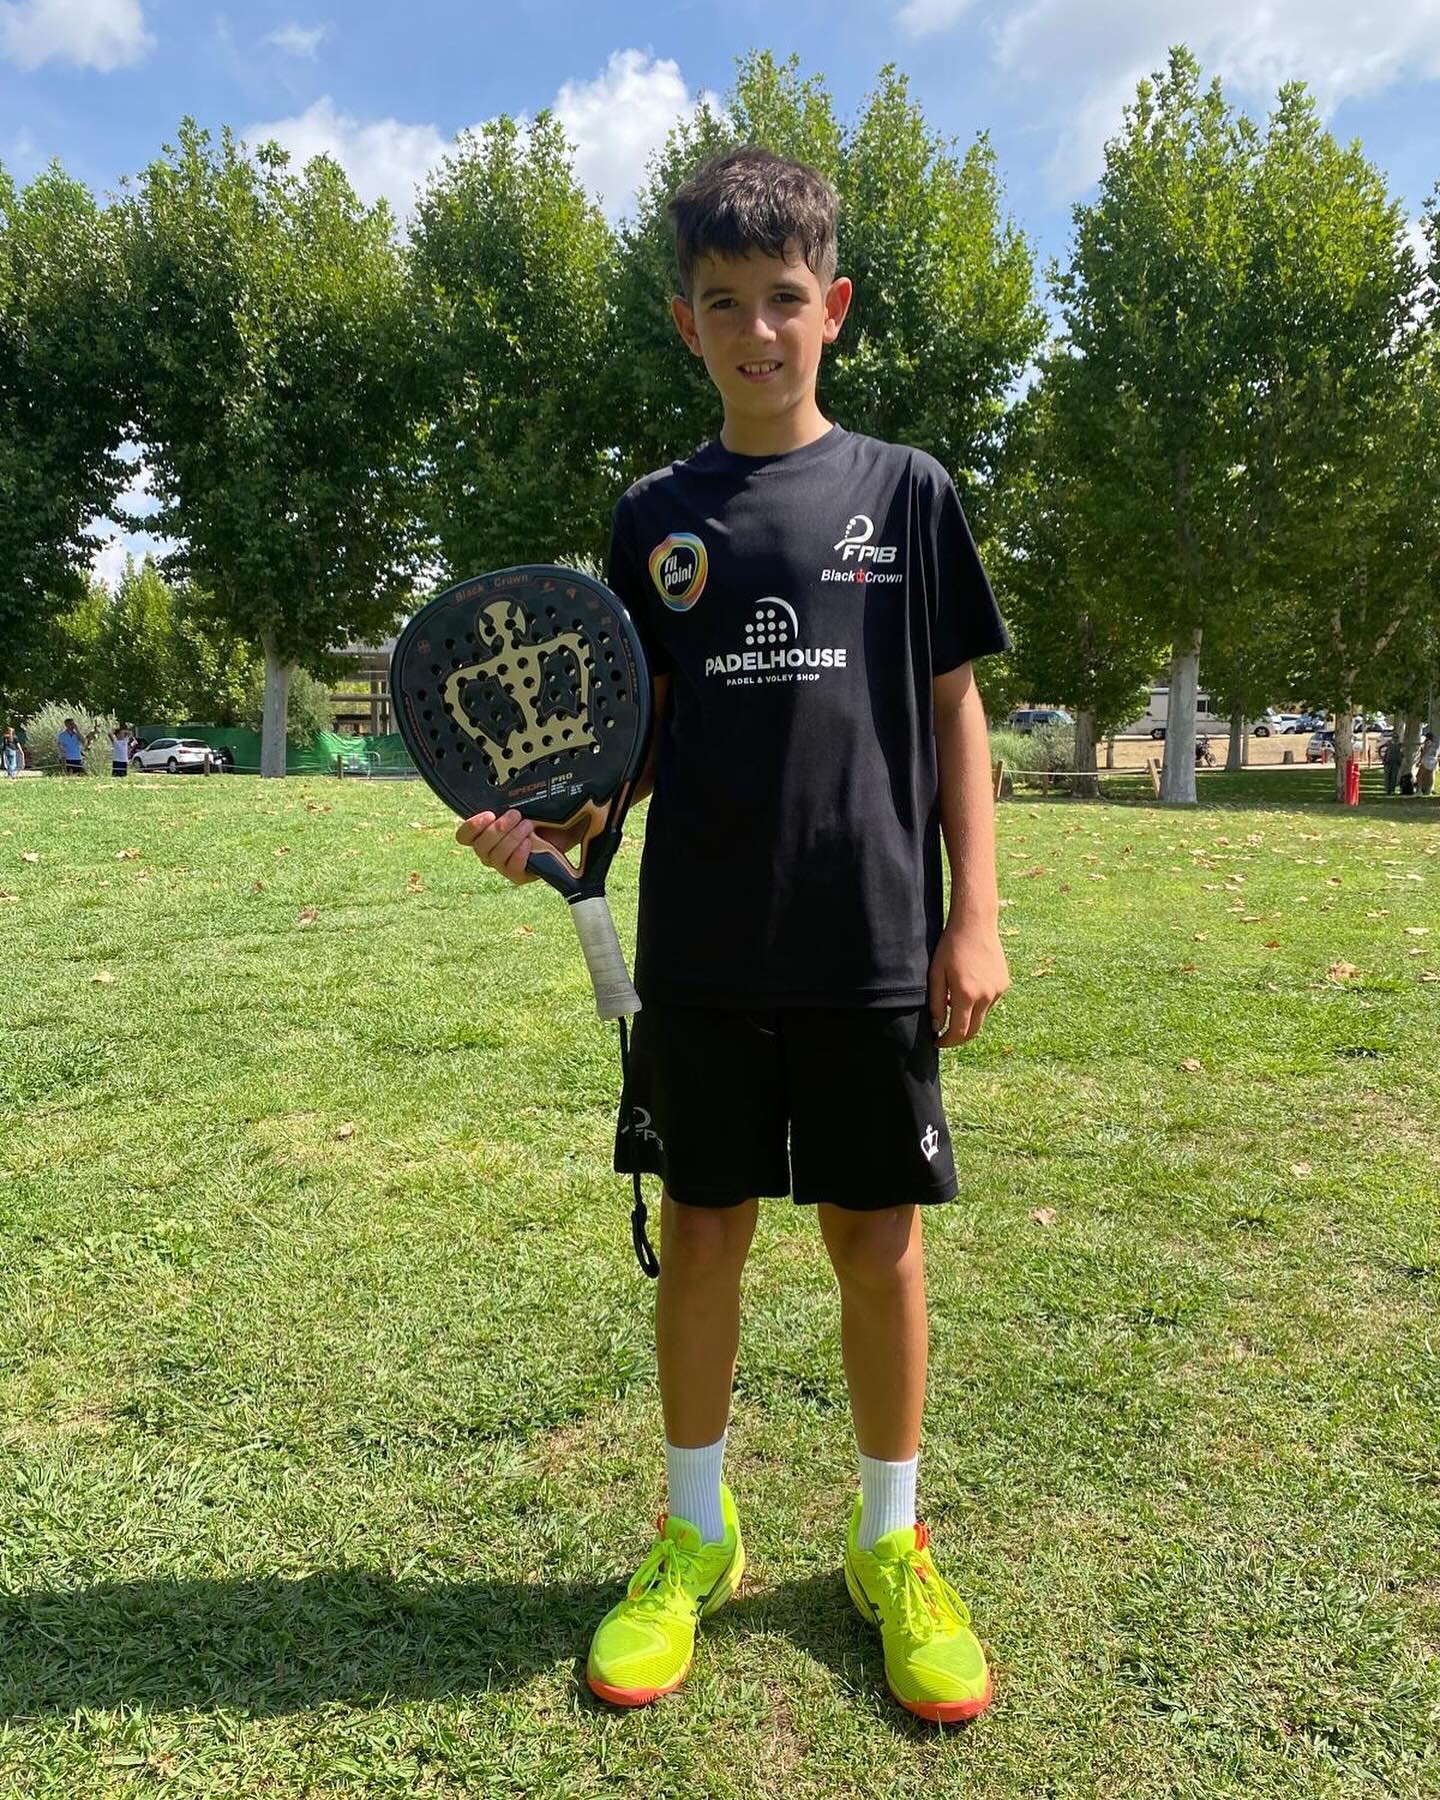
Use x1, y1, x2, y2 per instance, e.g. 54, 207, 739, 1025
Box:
929, 662, 1010, 1049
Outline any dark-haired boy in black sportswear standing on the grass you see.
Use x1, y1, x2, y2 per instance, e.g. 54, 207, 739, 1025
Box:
459, 149, 1008, 1721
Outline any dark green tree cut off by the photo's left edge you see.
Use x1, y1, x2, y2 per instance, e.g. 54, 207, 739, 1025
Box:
0, 164, 130, 700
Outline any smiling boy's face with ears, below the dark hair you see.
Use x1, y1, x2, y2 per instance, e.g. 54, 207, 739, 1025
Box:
671, 254, 851, 439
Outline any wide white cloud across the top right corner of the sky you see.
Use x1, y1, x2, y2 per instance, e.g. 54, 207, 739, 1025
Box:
898, 0, 1440, 194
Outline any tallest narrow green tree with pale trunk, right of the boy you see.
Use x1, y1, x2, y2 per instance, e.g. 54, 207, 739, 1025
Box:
1055, 49, 1256, 805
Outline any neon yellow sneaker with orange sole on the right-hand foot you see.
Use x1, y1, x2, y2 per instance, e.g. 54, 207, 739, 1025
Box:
844, 1494, 994, 1724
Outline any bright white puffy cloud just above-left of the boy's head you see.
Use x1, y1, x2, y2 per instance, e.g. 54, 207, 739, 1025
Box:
554, 50, 718, 218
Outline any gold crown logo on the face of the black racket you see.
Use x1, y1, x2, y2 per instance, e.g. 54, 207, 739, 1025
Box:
443, 599, 599, 787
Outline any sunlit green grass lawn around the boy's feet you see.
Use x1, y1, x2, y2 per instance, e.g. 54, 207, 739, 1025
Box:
0, 770, 1440, 1800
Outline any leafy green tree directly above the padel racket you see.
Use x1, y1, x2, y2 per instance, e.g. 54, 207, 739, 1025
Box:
410, 113, 614, 580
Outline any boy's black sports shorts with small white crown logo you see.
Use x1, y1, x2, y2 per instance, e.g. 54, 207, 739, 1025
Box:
616, 1004, 956, 1211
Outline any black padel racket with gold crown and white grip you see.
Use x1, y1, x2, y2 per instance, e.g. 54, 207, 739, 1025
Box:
391, 563, 650, 1019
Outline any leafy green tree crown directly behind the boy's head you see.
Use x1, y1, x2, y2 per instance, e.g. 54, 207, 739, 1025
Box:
605, 52, 1042, 535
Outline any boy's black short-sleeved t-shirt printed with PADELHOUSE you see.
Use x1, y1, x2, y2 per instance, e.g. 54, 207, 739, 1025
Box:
608, 427, 1010, 1006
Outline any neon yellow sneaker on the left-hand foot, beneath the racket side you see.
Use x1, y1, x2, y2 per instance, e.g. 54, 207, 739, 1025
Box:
585, 1483, 745, 1706
